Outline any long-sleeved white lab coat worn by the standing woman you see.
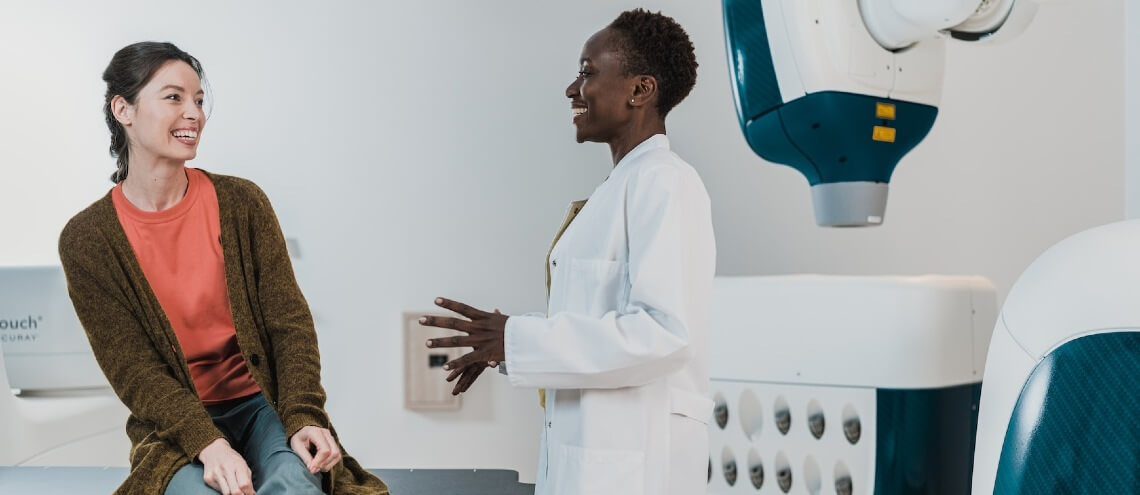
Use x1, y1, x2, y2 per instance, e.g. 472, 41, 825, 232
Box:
505, 135, 716, 495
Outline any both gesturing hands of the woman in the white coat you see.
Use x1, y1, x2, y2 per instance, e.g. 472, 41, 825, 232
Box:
420, 298, 507, 395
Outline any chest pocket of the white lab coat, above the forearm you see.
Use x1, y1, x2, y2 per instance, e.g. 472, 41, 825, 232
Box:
564, 258, 629, 317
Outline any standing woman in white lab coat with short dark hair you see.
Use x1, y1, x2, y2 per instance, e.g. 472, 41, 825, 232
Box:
421, 9, 716, 495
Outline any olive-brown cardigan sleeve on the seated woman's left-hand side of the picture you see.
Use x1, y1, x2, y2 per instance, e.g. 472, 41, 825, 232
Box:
59, 220, 223, 460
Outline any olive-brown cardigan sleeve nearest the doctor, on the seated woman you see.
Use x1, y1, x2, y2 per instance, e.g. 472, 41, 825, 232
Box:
241, 182, 329, 438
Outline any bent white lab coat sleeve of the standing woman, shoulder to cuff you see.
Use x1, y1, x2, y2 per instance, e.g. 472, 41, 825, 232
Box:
504, 167, 697, 389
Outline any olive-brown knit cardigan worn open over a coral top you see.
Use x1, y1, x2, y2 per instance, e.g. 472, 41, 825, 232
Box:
59, 173, 388, 495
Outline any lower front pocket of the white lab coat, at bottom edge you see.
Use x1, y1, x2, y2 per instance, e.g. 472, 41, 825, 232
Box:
554, 445, 645, 495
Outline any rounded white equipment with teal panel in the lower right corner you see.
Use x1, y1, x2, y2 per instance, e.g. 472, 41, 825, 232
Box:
972, 220, 1140, 495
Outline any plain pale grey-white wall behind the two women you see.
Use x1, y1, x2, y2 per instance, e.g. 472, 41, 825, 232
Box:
0, 0, 1124, 479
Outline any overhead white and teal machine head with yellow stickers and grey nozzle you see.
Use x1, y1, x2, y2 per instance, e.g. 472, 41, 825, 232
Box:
723, 0, 1039, 227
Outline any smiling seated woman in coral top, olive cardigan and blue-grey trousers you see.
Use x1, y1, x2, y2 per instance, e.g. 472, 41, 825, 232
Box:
59, 42, 388, 495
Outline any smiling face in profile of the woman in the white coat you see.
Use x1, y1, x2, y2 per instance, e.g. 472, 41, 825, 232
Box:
567, 29, 636, 143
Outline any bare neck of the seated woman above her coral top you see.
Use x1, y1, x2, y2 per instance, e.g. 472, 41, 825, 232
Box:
123, 149, 189, 211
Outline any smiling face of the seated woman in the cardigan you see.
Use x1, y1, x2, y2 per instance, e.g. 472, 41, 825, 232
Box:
115, 60, 206, 166
